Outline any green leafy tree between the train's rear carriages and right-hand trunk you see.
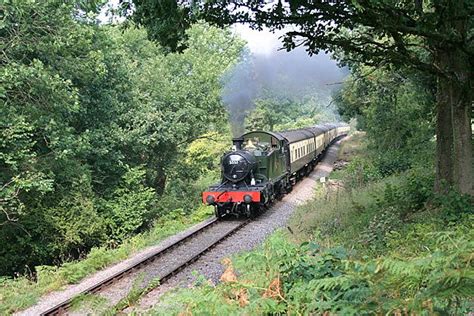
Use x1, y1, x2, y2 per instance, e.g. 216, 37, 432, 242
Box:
335, 66, 435, 175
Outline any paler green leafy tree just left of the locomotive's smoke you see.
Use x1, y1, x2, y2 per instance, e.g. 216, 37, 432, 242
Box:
114, 24, 243, 193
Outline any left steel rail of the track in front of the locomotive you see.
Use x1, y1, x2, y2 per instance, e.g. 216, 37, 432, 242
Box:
40, 218, 222, 316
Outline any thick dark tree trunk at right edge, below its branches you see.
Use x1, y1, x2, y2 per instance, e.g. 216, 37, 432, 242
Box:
435, 49, 474, 195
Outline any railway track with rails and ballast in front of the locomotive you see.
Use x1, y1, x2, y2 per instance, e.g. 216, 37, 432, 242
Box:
41, 218, 250, 315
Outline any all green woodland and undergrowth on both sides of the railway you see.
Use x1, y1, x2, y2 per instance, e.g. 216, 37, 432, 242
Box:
0, 0, 474, 315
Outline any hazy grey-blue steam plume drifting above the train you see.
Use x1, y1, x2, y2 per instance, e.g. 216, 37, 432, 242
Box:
222, 43, 348, 136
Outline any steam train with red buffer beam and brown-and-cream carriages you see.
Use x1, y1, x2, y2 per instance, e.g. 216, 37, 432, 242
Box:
202, 123, 349, 218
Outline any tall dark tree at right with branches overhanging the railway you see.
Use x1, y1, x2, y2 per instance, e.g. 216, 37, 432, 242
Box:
128, 0, 474, 195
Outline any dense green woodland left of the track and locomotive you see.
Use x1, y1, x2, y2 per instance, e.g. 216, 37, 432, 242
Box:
0, 1, 243, 275
